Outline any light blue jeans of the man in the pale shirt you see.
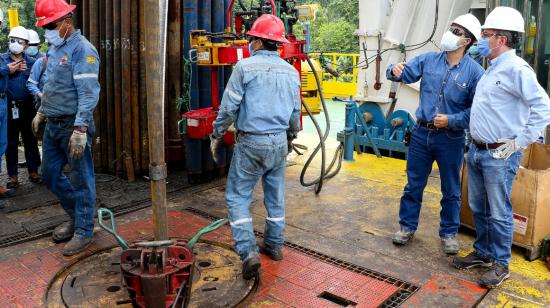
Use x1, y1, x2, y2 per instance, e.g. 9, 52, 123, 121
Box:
468, 146, 523, 266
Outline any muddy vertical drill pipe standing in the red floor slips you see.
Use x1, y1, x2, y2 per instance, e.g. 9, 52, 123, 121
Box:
145, 0, 168, 241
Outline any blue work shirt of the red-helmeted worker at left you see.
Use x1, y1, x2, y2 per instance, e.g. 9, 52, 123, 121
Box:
40, 30, 100, 126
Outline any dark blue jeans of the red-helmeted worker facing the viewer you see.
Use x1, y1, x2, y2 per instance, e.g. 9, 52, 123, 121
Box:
42, 118, 96, 238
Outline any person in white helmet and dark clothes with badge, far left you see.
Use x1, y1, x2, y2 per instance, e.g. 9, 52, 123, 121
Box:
0, 26, 41, 189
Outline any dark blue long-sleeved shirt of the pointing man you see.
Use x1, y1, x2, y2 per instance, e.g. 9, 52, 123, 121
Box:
386, 52, 483, 130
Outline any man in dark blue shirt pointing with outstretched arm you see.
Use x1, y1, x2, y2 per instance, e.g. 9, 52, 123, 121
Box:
386, 14, 483, 254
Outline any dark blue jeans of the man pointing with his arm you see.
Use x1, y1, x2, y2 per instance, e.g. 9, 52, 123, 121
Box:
399, 125, 465, 238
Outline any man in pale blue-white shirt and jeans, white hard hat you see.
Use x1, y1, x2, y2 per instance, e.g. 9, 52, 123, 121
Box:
453, 7, 550, 288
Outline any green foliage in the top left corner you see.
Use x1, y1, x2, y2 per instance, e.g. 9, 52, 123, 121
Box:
0, 0, 45, 52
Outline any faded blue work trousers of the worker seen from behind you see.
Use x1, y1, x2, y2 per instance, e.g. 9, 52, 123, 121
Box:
225, 132, 288, 260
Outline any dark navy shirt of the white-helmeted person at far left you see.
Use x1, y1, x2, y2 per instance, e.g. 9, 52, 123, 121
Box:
0, 52, 36, 101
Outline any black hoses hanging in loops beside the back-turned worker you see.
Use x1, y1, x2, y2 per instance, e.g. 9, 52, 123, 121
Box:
300, 57, 344, 194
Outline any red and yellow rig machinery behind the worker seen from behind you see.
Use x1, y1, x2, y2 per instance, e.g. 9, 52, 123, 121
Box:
183, 0, 310, 144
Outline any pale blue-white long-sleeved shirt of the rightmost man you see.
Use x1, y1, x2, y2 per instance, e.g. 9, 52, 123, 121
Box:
470, 50, 550, 147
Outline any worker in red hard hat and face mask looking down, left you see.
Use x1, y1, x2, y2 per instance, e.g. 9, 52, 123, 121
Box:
33, 0, 100, 256
